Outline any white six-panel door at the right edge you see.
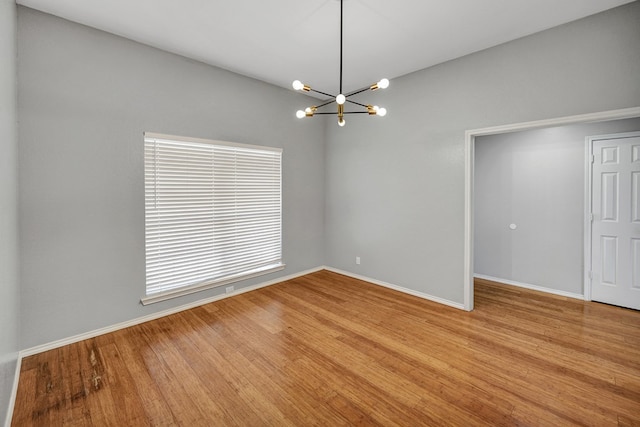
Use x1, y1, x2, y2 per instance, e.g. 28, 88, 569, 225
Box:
590, 132, 640, 310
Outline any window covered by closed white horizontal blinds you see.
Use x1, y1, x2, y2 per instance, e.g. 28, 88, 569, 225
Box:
142, 133, 284, 304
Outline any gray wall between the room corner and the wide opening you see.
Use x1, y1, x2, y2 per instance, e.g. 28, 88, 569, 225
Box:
325, 2, 640, 304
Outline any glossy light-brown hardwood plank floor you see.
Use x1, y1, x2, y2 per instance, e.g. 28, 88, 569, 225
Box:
12, 271, 640, 426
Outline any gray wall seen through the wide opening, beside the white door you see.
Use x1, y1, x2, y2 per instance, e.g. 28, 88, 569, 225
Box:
474, 119, 640, 295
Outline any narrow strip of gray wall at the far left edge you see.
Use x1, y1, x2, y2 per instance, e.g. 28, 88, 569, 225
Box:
0, 0, 20, 424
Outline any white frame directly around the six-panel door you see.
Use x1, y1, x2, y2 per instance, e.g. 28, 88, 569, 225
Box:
583, 131, 640, 301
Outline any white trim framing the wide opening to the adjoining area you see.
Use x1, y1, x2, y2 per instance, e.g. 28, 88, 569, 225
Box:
463, 107, 640, 311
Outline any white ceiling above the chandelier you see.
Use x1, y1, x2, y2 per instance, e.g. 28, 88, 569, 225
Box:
17, 0, 633, 97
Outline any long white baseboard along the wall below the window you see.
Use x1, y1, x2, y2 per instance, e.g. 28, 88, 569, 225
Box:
18, 267, 324, 359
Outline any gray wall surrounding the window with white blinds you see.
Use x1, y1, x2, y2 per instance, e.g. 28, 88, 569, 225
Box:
18, 7, 325, 348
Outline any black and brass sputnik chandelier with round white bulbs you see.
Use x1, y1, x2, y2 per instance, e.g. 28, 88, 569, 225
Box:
293, 0, 389, 126
